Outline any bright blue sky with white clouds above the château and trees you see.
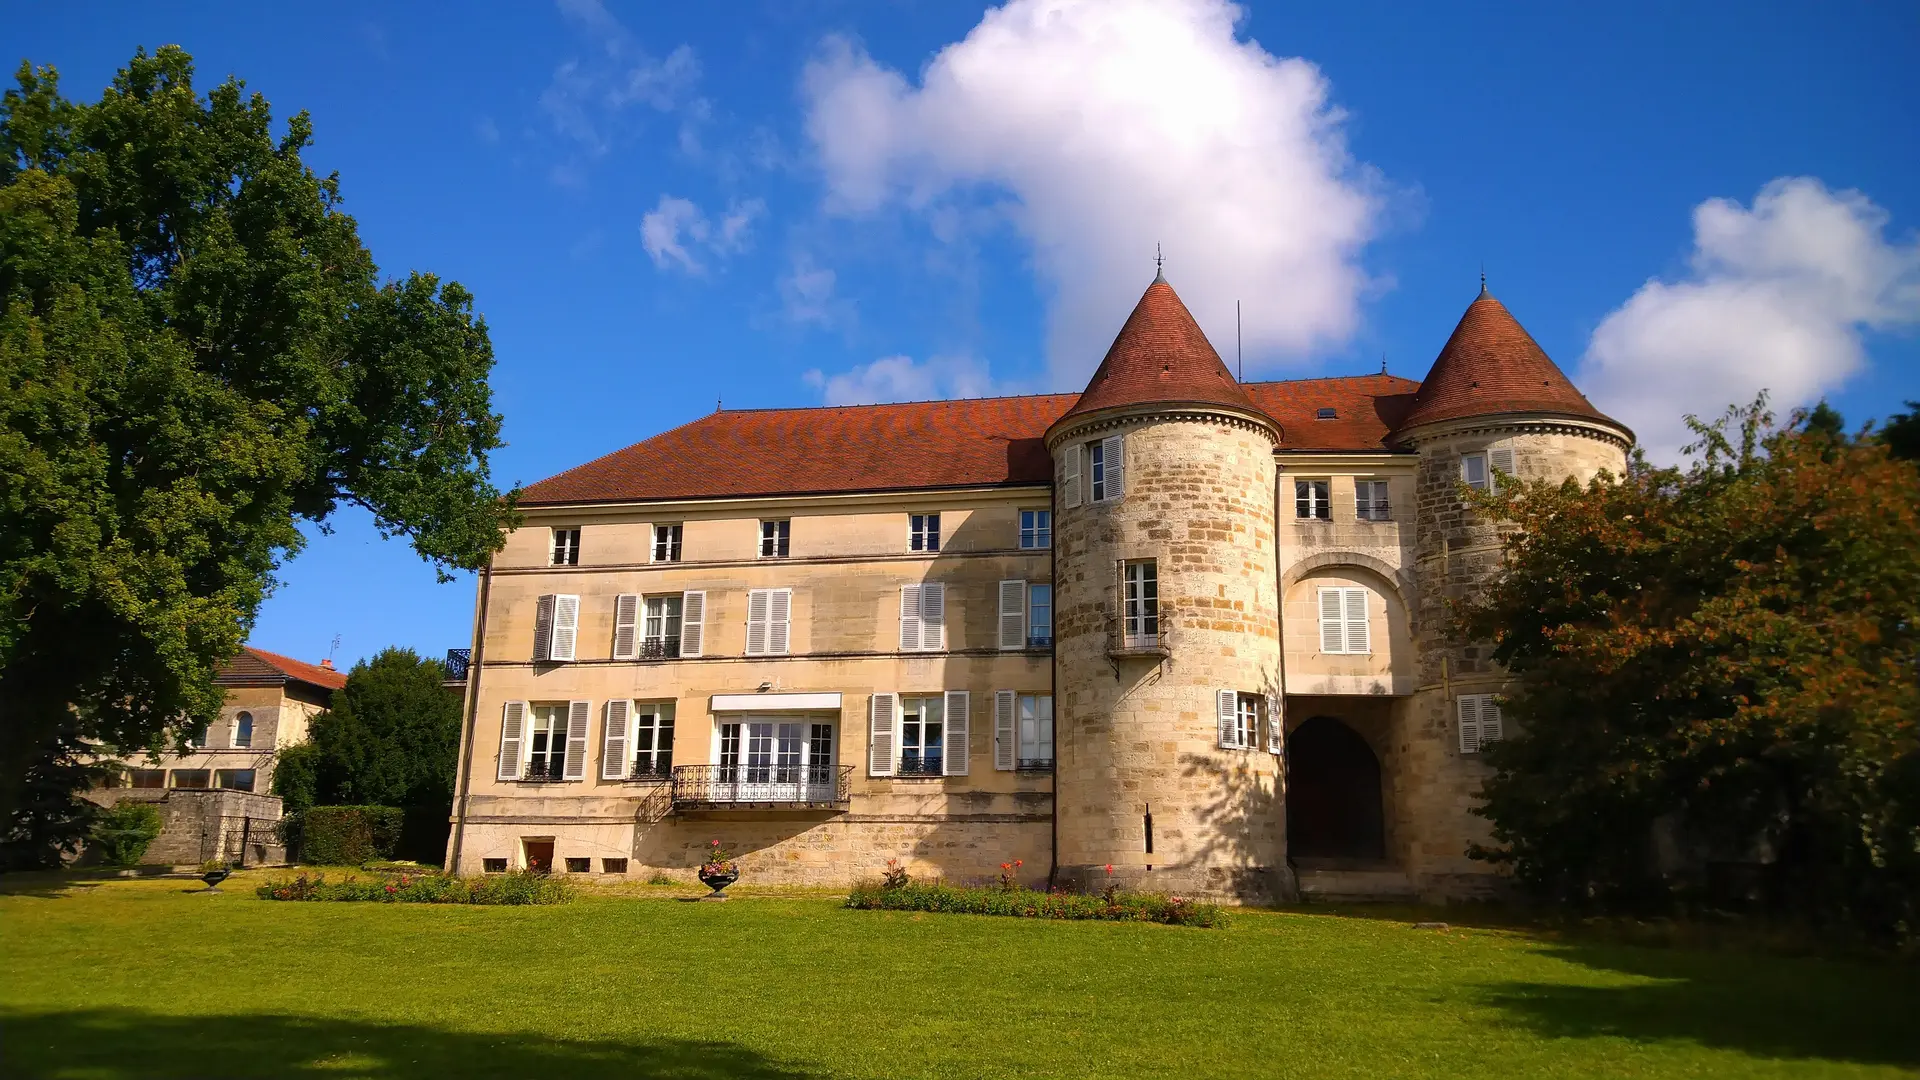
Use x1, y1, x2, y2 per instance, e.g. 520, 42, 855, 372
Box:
15, 0, 1920, 665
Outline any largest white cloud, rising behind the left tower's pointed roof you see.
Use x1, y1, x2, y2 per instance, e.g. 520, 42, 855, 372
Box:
803, 0, 1380, 388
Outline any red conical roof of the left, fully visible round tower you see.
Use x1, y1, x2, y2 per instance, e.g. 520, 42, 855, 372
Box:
1054, 275, 1265, 429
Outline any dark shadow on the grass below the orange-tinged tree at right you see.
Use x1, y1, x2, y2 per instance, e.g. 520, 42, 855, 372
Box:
1482, 944, 1920, 1067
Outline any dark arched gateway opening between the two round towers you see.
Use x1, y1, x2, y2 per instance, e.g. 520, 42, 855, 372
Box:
1286, 717, 1386, 859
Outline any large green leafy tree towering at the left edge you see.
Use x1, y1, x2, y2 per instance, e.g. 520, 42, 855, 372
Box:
0, 46, 513, 815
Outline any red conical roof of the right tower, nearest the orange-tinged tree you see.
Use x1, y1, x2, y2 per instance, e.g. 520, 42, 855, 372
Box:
1394, 284, 1626, 430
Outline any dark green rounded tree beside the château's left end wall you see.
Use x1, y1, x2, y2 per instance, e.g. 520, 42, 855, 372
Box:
273, 648, 461, 811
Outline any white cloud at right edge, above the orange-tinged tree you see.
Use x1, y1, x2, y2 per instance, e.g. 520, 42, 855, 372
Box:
1580, 177, 1920, 461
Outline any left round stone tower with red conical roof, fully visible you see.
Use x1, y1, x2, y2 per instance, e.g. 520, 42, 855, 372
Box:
1046, 277, 1292, 899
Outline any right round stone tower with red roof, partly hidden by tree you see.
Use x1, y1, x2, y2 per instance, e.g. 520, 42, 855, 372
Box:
1392, 282, 1634, 897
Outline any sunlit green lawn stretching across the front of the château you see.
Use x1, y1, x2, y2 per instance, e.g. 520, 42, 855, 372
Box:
0, 872, 1920, 1080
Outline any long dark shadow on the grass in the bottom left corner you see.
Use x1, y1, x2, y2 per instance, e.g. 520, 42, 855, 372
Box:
0, 1009, 814, 1080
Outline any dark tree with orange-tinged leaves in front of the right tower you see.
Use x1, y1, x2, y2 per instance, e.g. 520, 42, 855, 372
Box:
1459, 400, 1920, 936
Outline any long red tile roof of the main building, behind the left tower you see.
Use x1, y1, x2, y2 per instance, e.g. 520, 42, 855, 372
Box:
520, 375, 1417, 505
